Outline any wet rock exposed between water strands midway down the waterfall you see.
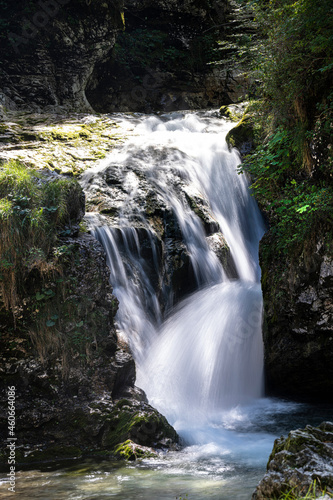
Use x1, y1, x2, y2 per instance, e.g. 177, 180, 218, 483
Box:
83, 139, 233, 304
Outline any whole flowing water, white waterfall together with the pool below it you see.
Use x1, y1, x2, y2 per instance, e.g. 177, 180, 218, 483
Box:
3, 112, 329, 500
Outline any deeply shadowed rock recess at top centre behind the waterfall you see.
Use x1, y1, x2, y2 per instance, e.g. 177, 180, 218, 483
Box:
87, 0, 231, 112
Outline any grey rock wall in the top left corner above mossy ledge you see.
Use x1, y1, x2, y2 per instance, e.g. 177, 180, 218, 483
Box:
0, 0, 123, 111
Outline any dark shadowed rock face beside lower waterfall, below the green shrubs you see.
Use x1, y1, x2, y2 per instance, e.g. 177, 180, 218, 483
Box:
260, 233, 333, 402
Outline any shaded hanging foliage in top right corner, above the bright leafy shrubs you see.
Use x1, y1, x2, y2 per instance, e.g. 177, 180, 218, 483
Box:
251, 0, 333, 172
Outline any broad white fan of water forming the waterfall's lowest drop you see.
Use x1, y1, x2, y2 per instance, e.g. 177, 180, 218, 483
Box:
138, 281, 263, 427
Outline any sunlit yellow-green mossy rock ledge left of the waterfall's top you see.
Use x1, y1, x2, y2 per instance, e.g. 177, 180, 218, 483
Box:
0, 112, 124, 175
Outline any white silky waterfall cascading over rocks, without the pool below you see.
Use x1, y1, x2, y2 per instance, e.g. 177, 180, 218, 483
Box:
82, 112, 265, 434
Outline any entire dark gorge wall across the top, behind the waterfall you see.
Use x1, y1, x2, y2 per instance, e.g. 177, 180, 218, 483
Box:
0, 0, 244, 112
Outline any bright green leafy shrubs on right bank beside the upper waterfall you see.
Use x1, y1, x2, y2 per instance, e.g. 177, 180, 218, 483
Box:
241, 128, 333, 255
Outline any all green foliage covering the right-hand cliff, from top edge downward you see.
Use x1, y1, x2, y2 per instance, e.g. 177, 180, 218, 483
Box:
237, 0, 333, 257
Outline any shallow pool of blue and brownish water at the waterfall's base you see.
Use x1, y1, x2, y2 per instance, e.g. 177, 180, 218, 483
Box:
0, 398, 333, 500
